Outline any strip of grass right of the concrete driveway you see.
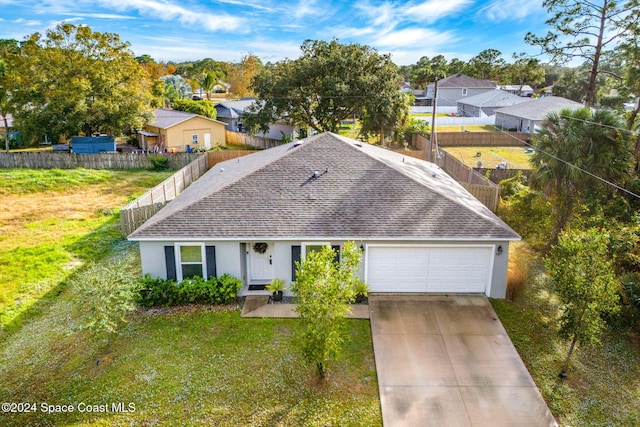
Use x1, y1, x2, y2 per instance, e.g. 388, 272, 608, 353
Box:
492, 246, 640, 426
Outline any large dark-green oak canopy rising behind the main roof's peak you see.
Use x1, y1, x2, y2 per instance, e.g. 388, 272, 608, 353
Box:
245, 40, 401, 139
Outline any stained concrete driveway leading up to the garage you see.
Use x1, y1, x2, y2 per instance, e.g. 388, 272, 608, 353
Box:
369, 295, 557, 427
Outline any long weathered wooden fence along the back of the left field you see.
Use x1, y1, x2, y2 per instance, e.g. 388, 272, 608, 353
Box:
0, 151, 200, 169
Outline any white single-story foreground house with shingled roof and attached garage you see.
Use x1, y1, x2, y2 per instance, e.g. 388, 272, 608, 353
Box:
128, 133, 519, 298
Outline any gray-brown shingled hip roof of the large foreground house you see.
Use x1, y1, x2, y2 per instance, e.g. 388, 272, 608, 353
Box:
129, 133, 519, 240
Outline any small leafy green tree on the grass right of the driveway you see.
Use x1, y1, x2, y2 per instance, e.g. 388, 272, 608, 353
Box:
545, 228, 620, 376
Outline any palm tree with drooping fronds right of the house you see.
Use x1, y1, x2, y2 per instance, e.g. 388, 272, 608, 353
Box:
530, 108, 631, 247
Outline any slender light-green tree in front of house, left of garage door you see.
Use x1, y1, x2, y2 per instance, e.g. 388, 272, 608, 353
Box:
291, 242, 361, 377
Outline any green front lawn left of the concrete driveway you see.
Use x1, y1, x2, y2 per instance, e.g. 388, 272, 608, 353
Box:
0, 244, 382, 426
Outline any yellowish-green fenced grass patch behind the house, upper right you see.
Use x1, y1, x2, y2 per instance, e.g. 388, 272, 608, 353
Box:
443, 147, 531, 169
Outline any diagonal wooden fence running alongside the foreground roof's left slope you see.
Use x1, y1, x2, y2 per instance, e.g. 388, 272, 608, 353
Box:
120, 156, 208, 236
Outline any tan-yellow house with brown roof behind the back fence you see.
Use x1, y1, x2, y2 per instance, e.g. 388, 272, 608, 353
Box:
138, 108, 226, 152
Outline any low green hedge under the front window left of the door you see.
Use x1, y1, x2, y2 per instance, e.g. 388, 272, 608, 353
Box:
138, 274, 242, 307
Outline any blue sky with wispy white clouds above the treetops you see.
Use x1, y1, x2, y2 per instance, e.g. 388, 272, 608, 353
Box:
0, 0, 547, 65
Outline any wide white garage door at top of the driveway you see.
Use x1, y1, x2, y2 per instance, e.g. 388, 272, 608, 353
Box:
367, 246, 493, 293
